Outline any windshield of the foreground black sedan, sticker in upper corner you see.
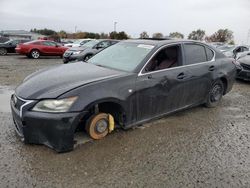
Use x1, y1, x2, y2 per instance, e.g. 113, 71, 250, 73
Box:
88, 43, 154, 72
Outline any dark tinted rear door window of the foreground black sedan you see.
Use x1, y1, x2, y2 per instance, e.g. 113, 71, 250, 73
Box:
184, 44, 207, 65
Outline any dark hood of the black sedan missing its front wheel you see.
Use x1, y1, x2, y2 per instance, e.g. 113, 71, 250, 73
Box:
15, 62, 126, 100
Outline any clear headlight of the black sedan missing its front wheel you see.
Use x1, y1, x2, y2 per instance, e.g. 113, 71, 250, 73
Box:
32, 97, 78, 112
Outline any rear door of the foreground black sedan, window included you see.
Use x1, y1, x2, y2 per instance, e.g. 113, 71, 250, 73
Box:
183, 43, 219, 105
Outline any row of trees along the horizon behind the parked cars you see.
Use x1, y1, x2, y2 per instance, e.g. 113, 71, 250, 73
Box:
30, 28, 234, 44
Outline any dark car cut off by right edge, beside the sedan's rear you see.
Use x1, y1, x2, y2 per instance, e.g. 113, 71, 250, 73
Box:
236, 51, 250, 81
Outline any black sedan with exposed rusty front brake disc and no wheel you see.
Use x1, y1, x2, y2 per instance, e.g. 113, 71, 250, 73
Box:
11, 40, 236, 152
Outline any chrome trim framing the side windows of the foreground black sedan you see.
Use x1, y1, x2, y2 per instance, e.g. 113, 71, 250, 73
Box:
138, 42, 216, 77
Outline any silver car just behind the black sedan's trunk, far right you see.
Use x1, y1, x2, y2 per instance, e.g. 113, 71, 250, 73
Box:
218, 45, 249, 58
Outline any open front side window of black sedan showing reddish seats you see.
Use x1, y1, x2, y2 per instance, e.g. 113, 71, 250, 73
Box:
143, 45, 181, 72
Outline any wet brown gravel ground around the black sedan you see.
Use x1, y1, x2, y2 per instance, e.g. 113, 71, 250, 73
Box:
0, 55, 250, 188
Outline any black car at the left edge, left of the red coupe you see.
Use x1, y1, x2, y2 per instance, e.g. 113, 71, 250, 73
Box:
0, 39, 30, 55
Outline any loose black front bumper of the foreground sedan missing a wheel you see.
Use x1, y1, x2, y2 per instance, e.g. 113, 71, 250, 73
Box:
11, 95, 87, 152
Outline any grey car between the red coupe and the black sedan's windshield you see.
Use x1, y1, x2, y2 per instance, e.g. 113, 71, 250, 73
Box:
63, 39, 119, 63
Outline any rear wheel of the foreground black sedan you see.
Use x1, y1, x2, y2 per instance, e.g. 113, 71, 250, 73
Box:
205, 80, 224, 108
